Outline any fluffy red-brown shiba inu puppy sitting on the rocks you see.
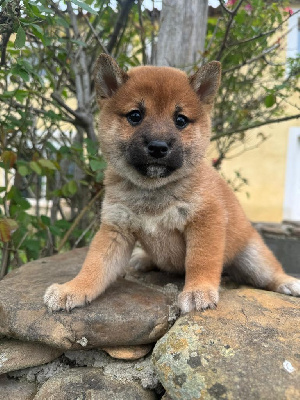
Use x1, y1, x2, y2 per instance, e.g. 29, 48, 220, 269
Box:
44, 54, 300, 313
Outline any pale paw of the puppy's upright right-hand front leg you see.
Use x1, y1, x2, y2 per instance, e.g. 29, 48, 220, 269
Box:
178, 288, 219, 314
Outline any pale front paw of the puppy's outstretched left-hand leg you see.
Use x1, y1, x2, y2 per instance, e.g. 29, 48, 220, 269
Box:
44, 283, 92, 312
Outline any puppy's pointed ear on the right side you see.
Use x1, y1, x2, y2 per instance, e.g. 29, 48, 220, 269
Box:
189, 61, 221, 108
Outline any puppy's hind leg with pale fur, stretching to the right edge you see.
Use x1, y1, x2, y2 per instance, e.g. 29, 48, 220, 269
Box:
228, 230, 300, 297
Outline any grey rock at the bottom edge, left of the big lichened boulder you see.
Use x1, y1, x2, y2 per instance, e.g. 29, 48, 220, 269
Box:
34, 368, 156, 400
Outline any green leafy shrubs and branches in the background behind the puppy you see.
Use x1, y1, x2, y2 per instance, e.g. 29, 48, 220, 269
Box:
0, 0, 300, 277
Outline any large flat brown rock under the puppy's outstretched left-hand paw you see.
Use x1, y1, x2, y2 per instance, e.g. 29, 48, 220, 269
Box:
0, 249, 173, 349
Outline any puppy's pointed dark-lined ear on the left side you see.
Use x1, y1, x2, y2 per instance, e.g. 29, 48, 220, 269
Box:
94, 53, 128, 100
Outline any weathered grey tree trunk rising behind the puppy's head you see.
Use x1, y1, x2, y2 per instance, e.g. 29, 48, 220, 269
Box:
156, 0, 208, 71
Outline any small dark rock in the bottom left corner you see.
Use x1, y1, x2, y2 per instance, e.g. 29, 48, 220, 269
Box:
0, 375, 36, 400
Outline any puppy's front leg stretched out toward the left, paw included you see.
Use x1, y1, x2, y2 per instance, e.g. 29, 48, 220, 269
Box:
44, 224, 135, 311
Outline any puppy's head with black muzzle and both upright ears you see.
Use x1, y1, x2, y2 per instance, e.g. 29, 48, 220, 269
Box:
95, 54, 221, 189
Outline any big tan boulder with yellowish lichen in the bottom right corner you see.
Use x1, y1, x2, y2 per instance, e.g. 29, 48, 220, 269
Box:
153, 287, 300, 400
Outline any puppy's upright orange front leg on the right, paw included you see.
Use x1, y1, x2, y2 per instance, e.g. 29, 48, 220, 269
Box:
178, 209, 225, 313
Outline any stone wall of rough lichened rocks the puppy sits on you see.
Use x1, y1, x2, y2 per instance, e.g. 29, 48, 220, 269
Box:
0, 245, 300, 400
